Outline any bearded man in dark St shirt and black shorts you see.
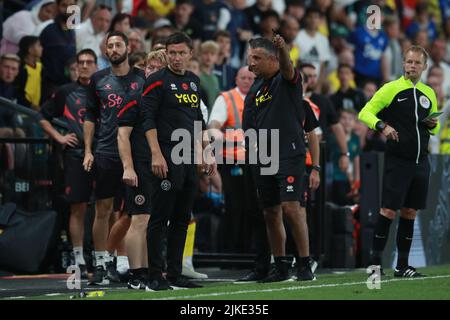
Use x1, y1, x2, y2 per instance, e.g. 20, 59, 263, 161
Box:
83, 31, 145, 284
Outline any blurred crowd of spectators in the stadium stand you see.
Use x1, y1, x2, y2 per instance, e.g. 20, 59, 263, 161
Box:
0, 0, 450, 258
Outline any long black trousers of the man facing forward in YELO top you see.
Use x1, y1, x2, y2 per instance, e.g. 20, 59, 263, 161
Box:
147, 162, 198, 277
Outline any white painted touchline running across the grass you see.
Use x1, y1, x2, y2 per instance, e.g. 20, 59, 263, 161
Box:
145, 275, 450, 300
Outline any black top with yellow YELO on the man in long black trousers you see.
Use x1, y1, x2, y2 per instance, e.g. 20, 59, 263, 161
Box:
141, 68, 206, 161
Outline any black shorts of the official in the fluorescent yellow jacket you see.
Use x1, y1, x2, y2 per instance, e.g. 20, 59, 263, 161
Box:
381, 154, 430, 210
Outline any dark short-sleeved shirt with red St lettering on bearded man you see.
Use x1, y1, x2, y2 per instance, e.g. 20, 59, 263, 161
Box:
85, 68, 145, 157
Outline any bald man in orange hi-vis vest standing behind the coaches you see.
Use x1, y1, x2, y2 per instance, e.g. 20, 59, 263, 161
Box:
209, 66, 265, 265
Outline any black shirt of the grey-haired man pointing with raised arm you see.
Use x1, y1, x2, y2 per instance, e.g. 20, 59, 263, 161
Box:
244, 71, 306, 161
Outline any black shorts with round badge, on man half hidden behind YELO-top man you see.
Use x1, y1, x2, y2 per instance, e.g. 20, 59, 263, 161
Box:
125, 161, 152, 215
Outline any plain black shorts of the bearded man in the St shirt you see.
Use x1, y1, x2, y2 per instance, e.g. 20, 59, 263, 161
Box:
95, 154, 125, 200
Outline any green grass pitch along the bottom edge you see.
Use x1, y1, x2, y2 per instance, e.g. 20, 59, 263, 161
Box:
21, 265, 450, 300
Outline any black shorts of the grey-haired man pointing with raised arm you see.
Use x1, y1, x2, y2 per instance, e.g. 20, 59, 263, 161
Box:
256, 157, 308, 208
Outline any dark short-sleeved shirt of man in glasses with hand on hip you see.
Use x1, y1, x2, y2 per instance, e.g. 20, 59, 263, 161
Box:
40, 82, 87, 156
